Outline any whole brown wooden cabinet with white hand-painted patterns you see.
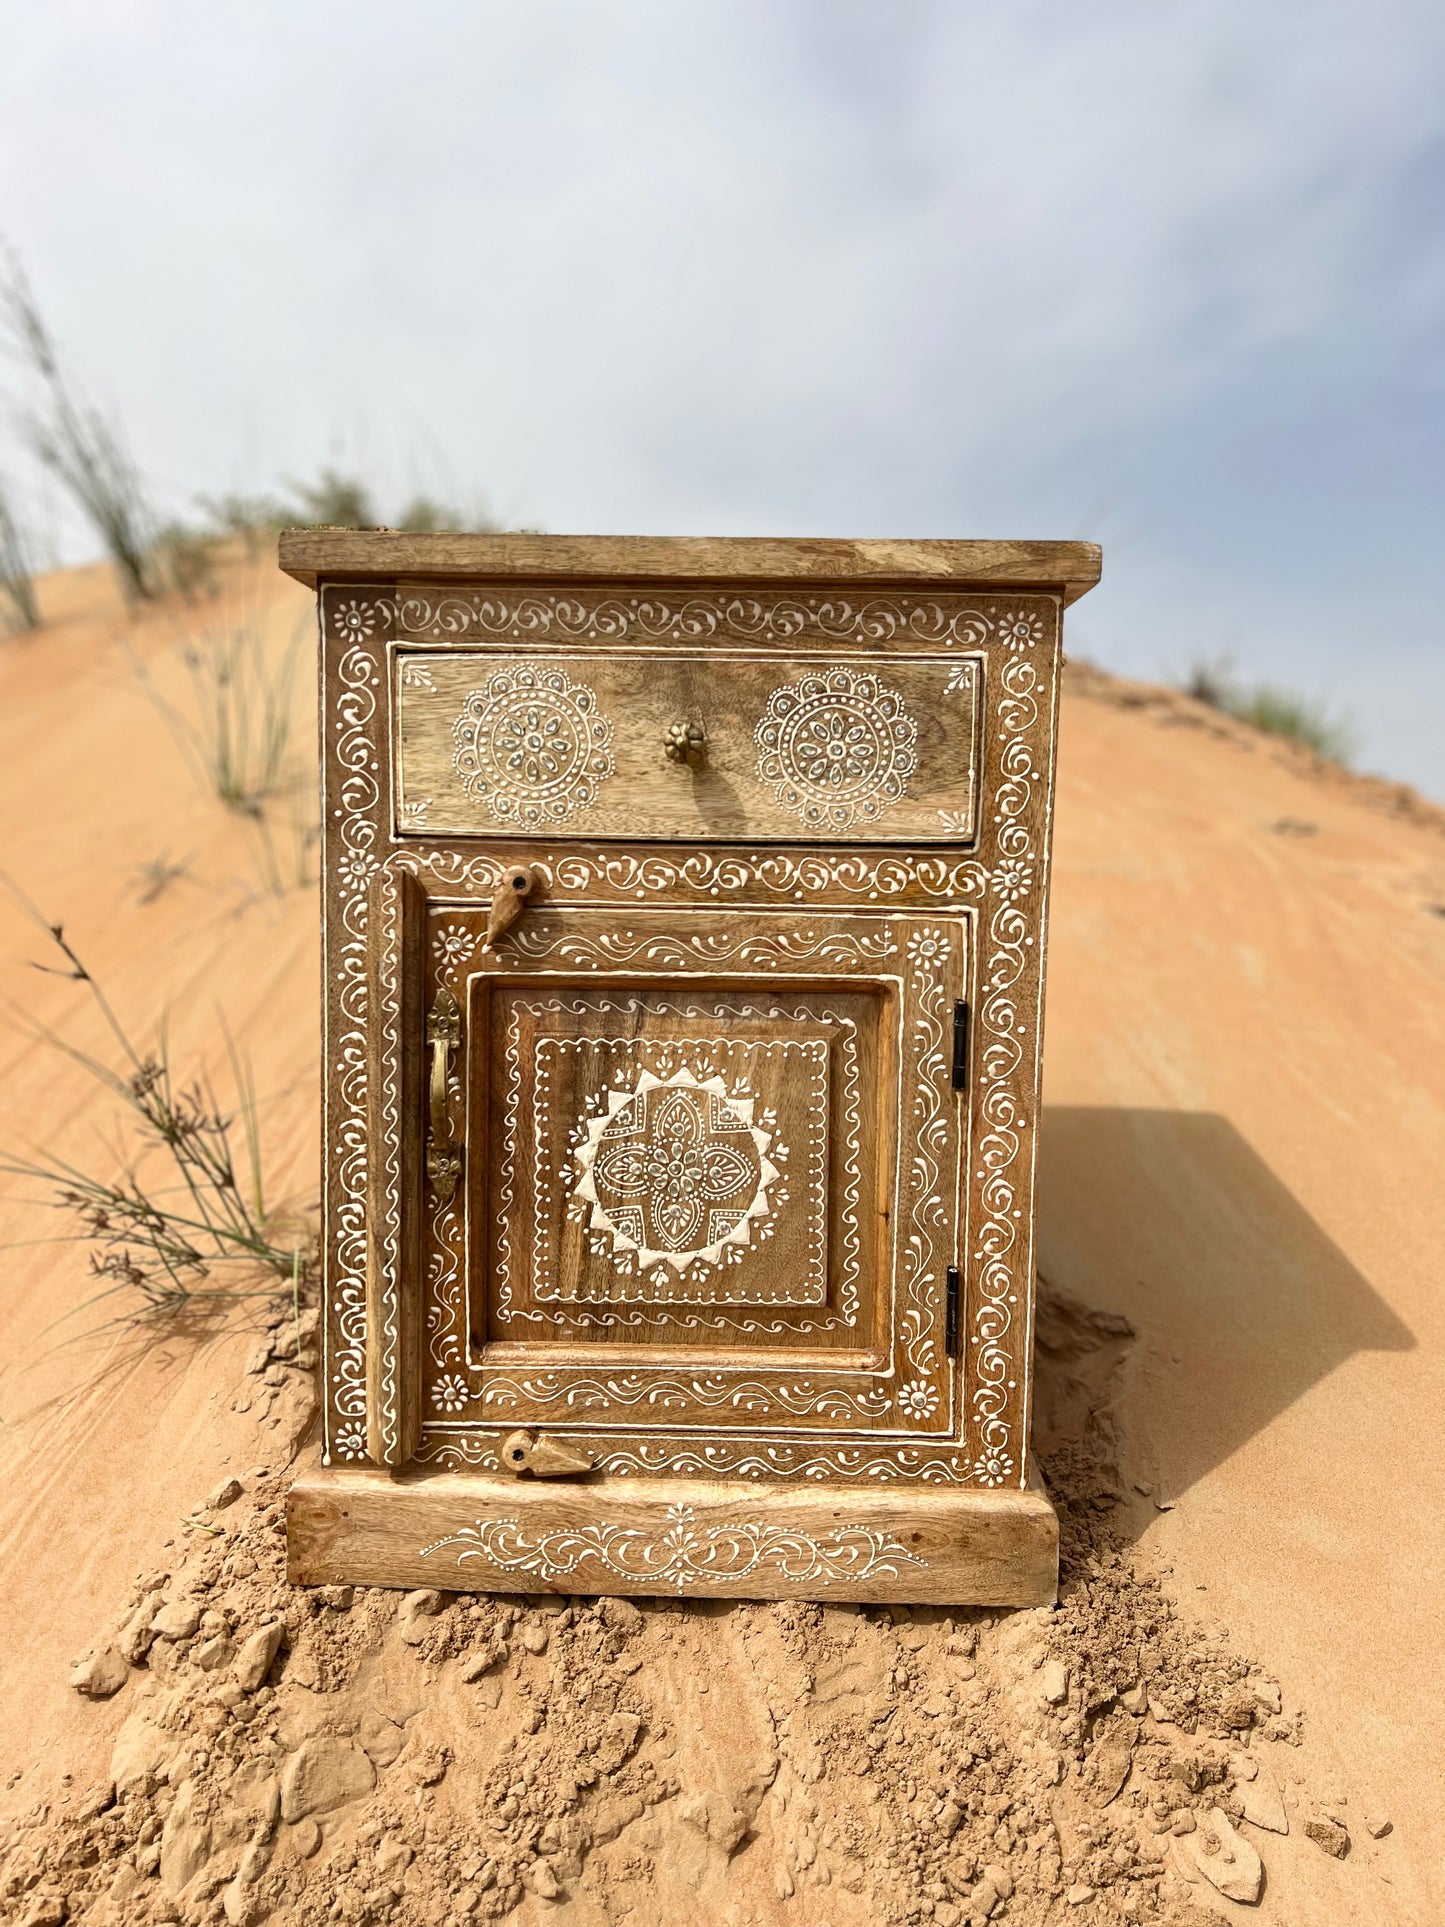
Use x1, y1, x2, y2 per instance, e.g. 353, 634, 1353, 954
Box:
281, 530, 1100, 1603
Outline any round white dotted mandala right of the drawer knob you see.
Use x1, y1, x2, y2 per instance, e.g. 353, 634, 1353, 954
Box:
753, 669, 919, 831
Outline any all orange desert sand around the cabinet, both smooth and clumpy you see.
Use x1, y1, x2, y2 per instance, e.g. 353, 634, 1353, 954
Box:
0, 559, 1445, 1927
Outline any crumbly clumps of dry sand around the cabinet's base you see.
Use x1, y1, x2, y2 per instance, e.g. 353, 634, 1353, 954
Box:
0, 1301, 1383, 1927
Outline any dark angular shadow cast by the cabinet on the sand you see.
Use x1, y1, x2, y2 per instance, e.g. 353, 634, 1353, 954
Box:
1038, 1106, 1416, 1497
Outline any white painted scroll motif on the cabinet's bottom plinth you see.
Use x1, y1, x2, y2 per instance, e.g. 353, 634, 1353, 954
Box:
420, 1505, 929, 1592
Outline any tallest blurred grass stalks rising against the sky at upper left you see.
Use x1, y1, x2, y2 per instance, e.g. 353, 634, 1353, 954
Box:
0, 256, 156, 601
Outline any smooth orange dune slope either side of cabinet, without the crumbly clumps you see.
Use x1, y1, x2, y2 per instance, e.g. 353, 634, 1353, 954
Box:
0, 551, 1445, 1927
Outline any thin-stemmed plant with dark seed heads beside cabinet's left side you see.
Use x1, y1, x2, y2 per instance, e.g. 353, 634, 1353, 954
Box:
0, 879, 314, 1324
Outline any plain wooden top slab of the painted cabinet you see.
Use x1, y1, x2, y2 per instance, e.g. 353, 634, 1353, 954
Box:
279, 528, 1102, 603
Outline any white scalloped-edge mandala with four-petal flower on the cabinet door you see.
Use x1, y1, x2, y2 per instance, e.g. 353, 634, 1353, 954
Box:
572, 1069, 780, 1272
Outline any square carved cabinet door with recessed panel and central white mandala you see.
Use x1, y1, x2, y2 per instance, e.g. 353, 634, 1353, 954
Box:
408, 904, 969, 1463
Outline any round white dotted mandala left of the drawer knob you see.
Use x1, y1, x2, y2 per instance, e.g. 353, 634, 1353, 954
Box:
451, 663, 613, 825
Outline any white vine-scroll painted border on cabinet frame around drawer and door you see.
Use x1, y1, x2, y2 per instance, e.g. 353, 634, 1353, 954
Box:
318, 584, 1058, 1486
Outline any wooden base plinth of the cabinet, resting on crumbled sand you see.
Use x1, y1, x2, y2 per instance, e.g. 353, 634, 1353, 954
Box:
287, 1466, 1058, 1605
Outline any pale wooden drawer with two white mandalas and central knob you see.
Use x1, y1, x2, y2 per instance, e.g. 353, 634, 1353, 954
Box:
391, 647, 983, 844
